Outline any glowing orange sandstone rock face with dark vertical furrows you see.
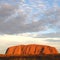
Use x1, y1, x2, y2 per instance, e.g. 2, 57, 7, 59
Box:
6, 44, 58, 56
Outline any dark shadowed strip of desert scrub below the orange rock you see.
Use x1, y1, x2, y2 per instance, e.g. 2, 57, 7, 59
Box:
0, 54, 60, 60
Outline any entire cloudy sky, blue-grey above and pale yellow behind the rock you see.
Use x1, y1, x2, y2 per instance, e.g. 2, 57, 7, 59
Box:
0, 0, 60, 54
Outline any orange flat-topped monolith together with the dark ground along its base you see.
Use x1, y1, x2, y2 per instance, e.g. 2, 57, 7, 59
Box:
0, 44, 60, 60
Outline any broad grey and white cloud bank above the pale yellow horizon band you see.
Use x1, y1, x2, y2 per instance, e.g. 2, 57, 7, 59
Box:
0, 0, 60, 34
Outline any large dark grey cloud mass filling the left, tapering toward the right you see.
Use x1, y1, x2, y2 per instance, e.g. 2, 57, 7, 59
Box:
0, 4, 45, 34
